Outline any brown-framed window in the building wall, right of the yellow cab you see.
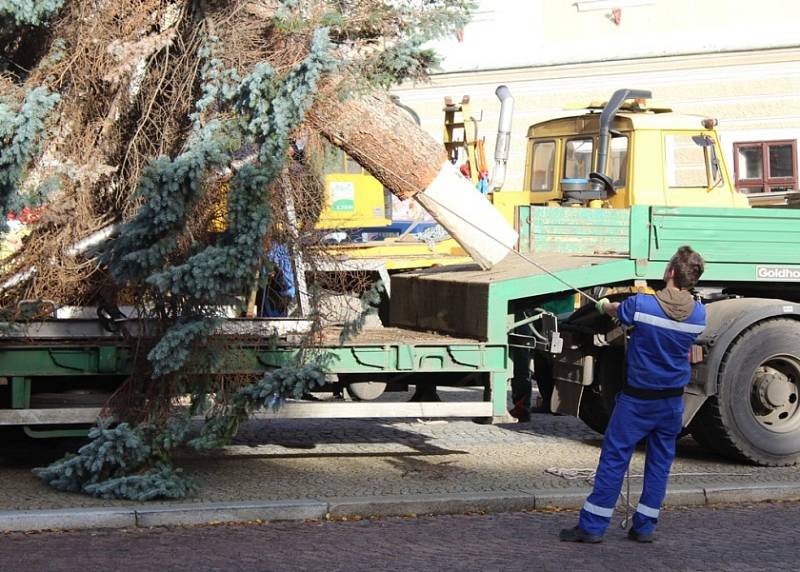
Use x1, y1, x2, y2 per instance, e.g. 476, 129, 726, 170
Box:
733, 140, 797, 194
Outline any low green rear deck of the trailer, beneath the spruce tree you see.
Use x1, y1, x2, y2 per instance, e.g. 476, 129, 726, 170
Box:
0, 319, 509, 437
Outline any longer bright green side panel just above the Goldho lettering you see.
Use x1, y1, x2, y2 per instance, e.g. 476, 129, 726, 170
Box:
650, 207, 800, 265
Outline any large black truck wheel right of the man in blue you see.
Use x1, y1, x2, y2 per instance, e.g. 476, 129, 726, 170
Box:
691, 319, 800, 465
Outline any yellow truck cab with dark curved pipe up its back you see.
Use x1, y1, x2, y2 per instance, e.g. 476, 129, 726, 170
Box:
525, 90, 749, 208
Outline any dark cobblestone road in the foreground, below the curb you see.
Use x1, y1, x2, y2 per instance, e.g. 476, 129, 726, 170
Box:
0, 503, 800, 572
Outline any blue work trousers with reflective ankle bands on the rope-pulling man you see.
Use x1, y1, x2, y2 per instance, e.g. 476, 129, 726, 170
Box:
578, 394, 683, 536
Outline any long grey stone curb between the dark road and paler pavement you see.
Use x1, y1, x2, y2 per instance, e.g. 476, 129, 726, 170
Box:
0, 483, 800, 532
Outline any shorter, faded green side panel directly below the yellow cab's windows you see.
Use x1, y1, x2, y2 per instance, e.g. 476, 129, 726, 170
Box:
529, 207, 630, 254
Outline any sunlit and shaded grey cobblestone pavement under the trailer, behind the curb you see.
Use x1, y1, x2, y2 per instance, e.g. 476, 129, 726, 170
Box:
0, 390, 800, 510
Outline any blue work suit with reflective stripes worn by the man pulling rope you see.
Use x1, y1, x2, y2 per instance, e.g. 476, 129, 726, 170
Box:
578, 294, 706, 536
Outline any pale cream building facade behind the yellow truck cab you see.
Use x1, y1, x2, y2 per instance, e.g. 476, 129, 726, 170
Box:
394, 0, 800, 201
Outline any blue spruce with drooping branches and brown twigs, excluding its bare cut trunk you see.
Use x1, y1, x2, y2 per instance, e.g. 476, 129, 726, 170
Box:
0, 0, 472, 500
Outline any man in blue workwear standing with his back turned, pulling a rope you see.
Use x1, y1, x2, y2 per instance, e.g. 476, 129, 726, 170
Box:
559, 246, 706, 543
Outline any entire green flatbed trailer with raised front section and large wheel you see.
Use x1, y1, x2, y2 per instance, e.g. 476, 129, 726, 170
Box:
0, 206, 800, 464
